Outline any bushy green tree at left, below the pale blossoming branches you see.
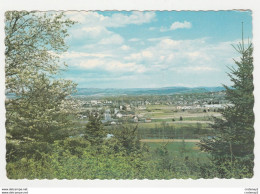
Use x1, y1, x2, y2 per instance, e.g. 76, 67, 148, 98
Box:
8, 74, 74, 143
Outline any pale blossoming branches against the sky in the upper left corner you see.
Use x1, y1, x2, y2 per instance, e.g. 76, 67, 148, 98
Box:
5, 11, 74, 80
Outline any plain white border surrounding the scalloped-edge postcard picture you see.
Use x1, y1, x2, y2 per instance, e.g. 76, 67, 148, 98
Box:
0, 0, 260, 188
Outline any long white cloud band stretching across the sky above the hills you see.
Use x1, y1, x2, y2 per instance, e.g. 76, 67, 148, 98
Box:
65, 36, 235, 76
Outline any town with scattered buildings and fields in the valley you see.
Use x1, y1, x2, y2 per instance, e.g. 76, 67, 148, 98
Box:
70, 91, 232, 125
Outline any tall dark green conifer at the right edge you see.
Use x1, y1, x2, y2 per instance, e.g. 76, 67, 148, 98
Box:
200, 29, 254, 178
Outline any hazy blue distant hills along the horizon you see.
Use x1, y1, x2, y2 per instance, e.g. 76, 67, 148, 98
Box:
74, 87, 225, 96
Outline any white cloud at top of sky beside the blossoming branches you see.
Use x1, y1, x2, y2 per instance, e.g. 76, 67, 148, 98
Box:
66, 11, 156, 48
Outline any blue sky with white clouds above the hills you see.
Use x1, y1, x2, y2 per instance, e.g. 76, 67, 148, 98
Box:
60, 11, 252, 88
